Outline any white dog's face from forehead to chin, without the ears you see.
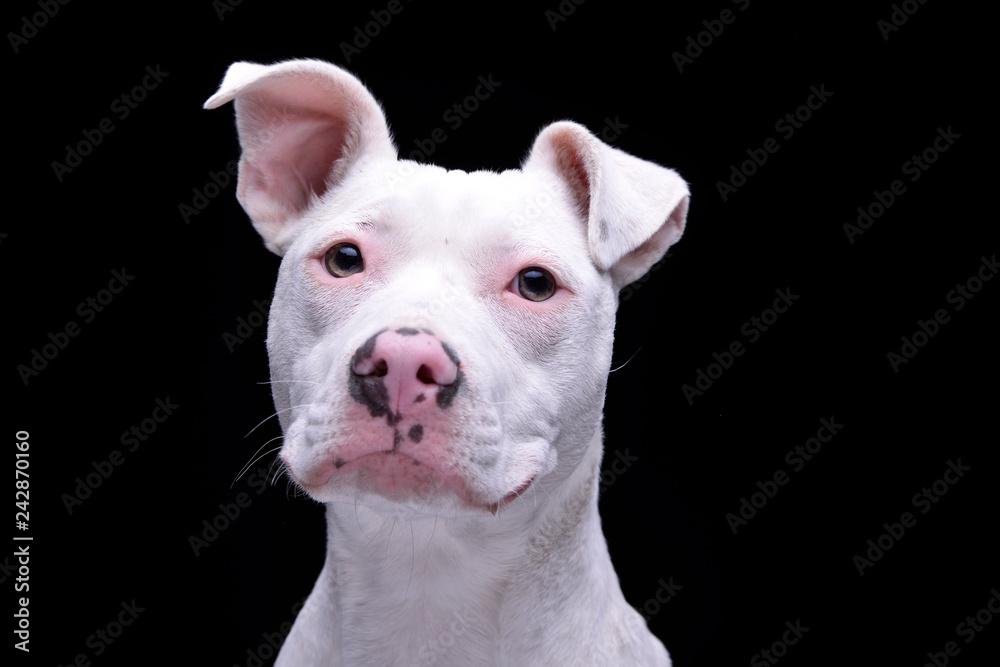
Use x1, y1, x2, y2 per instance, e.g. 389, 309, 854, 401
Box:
268, 161, 615, 512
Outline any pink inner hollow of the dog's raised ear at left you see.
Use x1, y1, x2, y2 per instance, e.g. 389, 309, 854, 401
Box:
244, 115, 345, 213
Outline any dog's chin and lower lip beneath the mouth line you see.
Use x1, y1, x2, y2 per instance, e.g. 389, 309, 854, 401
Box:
292, 451, 535, 517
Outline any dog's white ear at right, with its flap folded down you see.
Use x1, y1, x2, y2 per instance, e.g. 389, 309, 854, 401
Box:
524, 121, 690, 289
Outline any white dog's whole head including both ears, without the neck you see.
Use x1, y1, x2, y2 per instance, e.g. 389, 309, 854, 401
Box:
206, 61, 687, 515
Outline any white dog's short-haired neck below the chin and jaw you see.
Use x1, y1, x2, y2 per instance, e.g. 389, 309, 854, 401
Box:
302, 433, 648, 665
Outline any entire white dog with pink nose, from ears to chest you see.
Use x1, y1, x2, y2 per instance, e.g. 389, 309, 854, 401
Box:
205, 60, 688, 667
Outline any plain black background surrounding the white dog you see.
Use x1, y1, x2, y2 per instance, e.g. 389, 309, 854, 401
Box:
0, 0, 1000, 667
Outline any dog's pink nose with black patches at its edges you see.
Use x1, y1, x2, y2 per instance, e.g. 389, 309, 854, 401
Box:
348, 327, 462, 425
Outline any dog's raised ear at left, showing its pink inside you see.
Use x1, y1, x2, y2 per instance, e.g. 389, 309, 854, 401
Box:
205, 60, 396, 255
